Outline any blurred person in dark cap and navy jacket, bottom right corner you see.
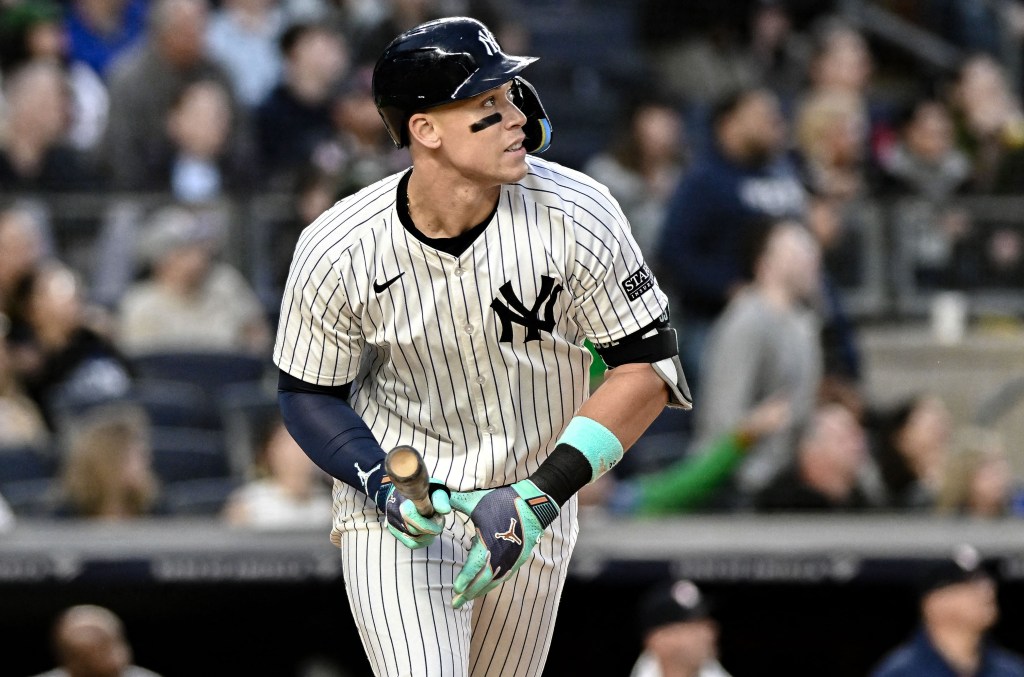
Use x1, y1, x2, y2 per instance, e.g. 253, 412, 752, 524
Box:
871, 547, 1024, 677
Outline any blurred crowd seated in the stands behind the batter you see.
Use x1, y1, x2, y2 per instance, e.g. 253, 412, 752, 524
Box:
0, 0, 1024, 527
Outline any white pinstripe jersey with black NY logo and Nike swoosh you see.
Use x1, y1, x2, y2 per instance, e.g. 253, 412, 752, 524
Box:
274, 157, 668, 526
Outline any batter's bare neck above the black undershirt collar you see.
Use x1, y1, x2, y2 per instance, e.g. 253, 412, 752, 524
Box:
408, 171, 501, 238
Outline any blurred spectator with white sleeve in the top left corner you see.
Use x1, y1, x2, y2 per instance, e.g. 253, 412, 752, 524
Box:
0, 0, 110, 152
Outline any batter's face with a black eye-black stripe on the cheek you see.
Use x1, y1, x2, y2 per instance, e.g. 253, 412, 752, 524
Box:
431, 82, 526, 184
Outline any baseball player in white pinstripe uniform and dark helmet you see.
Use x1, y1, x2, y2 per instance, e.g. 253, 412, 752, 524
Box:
274, 17, 690, 677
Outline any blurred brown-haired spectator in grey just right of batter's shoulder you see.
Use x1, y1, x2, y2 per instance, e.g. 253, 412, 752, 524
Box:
584, 96, 686, 258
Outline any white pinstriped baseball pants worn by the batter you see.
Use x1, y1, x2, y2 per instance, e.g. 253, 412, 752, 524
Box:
341, 497, 579, 677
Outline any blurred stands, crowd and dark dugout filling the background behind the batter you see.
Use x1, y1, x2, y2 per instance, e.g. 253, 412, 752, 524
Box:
0, 0, 1024, 677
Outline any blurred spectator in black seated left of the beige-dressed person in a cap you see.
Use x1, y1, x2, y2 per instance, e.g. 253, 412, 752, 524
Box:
7, 261, 132, 429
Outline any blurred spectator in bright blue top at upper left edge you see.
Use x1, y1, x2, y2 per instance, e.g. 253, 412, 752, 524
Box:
65, 0, 148, 79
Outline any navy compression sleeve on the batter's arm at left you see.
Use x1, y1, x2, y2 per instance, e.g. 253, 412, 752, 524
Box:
278, 372, 385, 503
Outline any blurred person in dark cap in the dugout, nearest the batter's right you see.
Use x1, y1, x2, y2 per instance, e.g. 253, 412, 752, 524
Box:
630, 580, 729, 677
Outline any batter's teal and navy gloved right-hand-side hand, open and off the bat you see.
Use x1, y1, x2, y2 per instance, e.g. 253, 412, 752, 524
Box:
452, 479, 558, 608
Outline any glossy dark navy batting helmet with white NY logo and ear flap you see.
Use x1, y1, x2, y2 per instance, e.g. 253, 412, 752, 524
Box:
373, 16, 551, 153
